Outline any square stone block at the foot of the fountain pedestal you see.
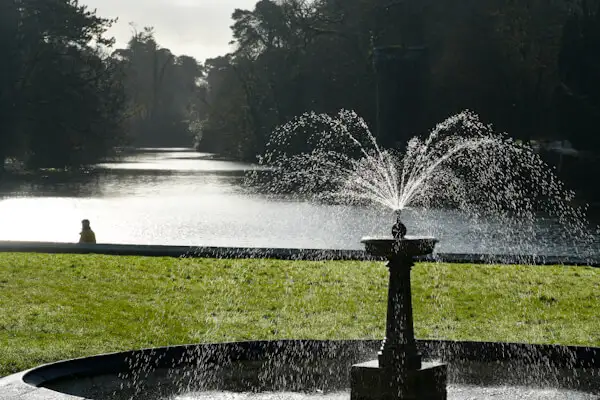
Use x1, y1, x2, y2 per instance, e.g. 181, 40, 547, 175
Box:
350, 360, 448, 400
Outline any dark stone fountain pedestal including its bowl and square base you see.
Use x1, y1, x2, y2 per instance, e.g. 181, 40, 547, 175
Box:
350, 237, 447, 400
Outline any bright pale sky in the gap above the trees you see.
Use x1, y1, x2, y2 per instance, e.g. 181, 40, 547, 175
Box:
80, 0, 257, 62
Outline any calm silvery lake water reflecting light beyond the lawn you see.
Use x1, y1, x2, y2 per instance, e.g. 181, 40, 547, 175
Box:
0, 149, 600, 255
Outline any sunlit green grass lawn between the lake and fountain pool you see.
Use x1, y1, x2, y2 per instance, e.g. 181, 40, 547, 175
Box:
0, 253, 600, 376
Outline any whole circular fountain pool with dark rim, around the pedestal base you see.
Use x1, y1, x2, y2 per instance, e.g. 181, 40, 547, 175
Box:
0, 341, 600, 400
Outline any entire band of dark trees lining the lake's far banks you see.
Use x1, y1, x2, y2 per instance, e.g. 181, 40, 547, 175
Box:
0, 0, 600, 202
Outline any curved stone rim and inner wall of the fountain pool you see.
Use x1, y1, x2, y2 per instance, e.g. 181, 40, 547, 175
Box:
0, 340, 600, 400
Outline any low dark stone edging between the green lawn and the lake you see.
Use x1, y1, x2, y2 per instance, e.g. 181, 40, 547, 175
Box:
0, 241, 600, 267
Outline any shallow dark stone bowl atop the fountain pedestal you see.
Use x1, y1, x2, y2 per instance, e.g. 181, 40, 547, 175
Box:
361, 236, 438, 259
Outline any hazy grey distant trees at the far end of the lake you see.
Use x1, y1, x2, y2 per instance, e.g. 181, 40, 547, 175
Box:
113, 28, 206, 147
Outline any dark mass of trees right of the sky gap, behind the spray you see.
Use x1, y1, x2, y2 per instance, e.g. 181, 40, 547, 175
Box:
199, 0, 600, 200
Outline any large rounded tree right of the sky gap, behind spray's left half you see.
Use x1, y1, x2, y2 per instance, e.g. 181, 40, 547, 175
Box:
200, 0, 374, 160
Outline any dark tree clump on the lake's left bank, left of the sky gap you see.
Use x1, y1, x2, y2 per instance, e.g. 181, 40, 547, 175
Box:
0, 0, 125, 168
